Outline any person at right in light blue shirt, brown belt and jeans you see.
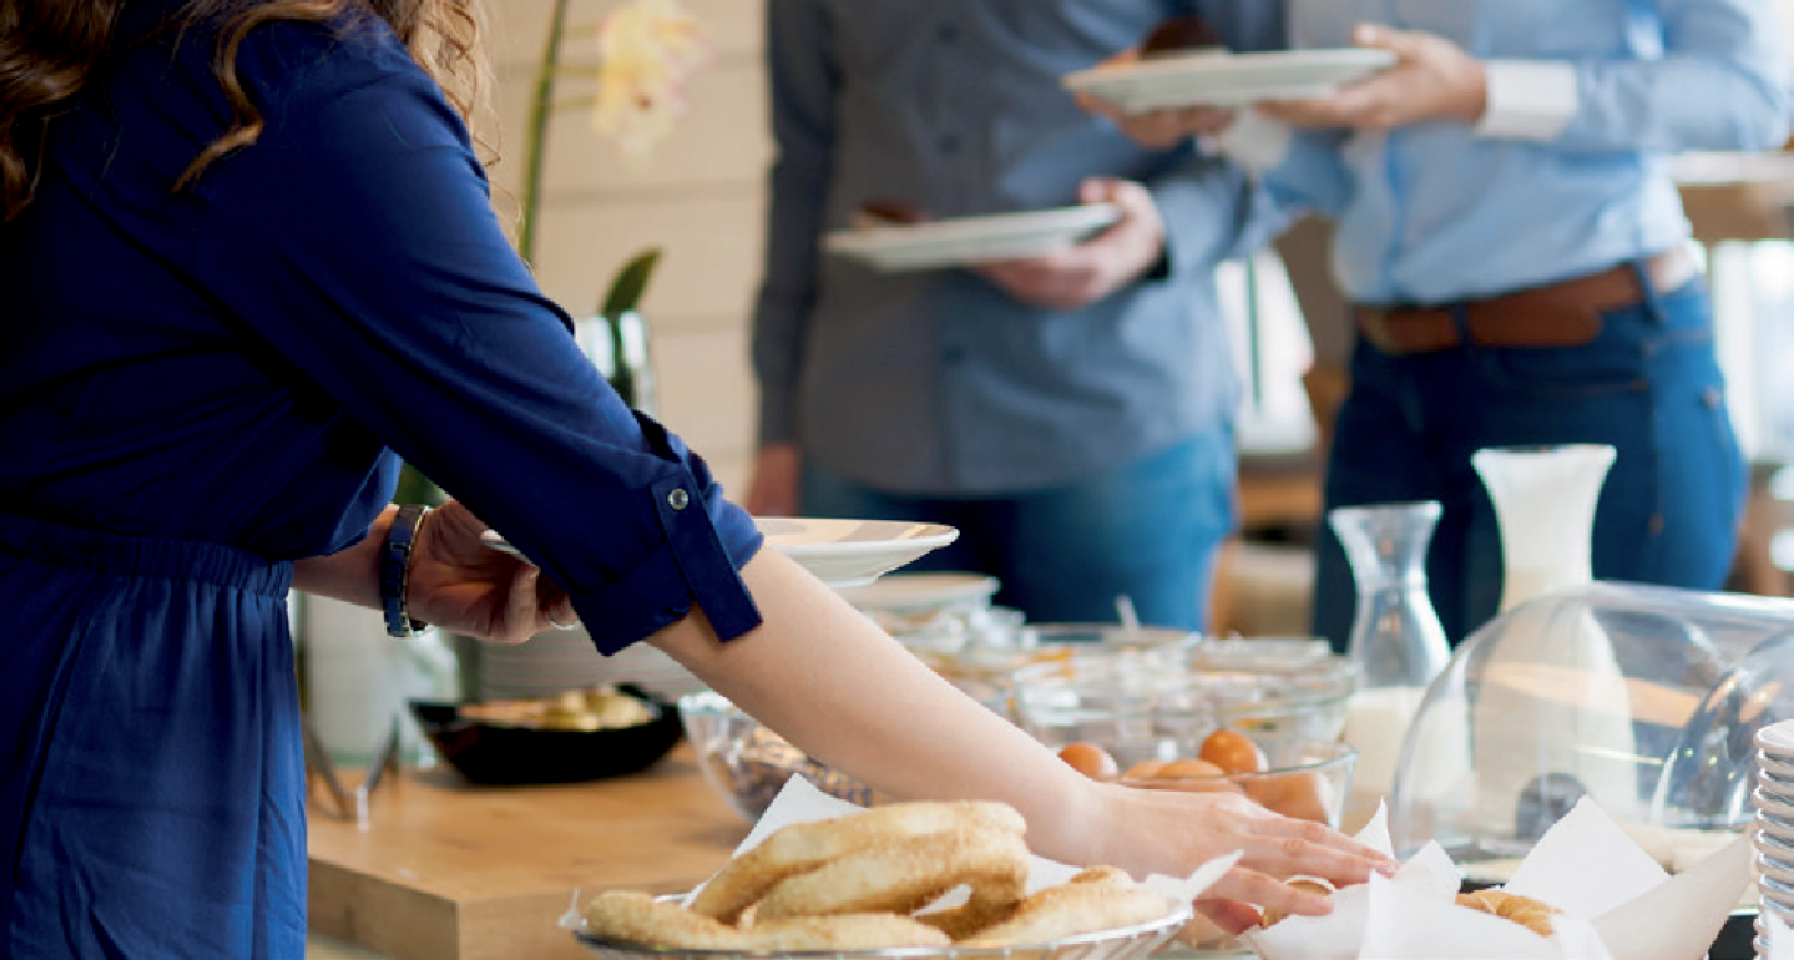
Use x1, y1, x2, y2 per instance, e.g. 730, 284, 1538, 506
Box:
1090, 0, 1789, 646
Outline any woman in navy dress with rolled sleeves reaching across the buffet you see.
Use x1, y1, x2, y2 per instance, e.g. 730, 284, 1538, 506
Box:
0, 0, 1387, 960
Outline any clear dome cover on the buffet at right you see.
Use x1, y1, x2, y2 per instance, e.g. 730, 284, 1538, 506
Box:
1390, 583, 1794, 876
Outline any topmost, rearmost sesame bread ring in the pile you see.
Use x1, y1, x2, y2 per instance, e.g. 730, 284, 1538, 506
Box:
691, 800, 1026, 922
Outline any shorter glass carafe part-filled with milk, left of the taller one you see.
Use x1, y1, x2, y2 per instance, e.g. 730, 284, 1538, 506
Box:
1328, 501, 1451, 797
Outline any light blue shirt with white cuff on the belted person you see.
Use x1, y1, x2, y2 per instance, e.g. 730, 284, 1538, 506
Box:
1241, 0, 1789, 303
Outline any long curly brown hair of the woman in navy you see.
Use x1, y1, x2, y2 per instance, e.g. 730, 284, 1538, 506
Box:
0, 0, 486, 221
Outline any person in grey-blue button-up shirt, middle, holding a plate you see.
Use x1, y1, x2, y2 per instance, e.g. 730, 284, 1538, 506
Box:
746, 0, 1285, 628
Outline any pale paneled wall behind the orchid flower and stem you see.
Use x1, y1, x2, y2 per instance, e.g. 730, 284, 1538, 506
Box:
486, 0, 771, 493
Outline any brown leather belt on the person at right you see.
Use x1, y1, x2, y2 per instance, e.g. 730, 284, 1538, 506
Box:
1353, 246, 1701, 355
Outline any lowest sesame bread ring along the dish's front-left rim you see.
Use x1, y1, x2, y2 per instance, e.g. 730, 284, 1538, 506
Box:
585, 890, 949, 953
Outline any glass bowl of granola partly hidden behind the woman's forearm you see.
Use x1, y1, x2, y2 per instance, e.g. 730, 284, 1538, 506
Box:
678, 691, 881, 822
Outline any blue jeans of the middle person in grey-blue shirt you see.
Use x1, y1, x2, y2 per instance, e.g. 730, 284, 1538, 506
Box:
802, 429, 1236, 630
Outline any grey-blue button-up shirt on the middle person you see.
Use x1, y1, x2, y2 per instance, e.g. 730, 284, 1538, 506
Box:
753, 0, 1283, 493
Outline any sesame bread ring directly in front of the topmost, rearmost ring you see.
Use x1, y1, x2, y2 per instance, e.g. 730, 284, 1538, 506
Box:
755, 829, 1028, 922
